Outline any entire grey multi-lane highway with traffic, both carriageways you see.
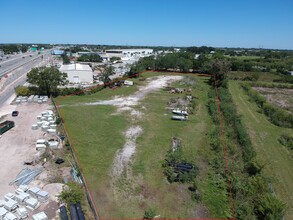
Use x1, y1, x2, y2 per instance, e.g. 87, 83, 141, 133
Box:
0, 51, 49, 108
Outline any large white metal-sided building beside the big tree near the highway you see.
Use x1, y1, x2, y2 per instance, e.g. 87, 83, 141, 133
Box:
59, 63, 93, 83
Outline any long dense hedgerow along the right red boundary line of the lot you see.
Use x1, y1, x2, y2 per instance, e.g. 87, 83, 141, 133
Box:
208, 59, 285, 219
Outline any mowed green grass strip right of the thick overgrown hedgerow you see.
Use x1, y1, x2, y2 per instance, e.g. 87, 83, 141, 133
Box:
229, 81, 293, 219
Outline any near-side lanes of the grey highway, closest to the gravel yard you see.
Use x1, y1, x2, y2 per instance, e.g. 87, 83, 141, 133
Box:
0, 52, 48, 108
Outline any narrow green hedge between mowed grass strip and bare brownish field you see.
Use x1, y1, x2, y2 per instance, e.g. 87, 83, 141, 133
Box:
242, 84, 293, 128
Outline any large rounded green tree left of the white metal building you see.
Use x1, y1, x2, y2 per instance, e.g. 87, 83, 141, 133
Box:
27, 67, 67, 96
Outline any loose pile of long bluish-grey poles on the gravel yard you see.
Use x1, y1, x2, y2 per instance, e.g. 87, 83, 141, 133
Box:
10, 167, 44, 186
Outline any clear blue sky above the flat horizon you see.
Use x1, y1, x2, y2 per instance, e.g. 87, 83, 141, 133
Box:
0, 0, 293, 49
